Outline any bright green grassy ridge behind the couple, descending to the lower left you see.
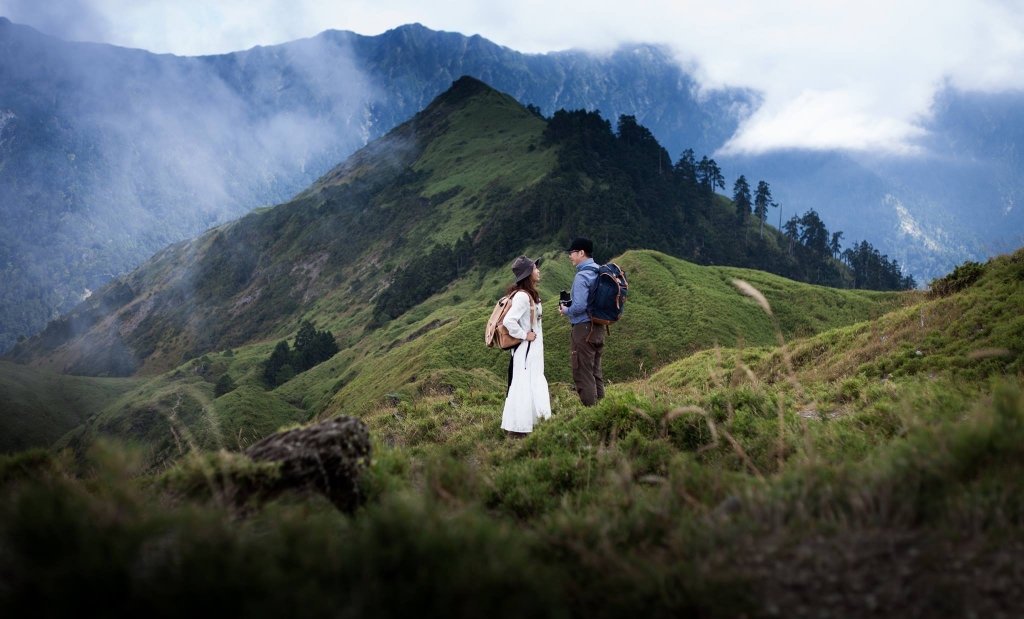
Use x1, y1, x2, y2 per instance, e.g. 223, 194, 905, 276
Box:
6, 251, 909, 467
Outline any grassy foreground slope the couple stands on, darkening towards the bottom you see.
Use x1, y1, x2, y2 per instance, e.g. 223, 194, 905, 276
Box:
0, 252, 1024, 617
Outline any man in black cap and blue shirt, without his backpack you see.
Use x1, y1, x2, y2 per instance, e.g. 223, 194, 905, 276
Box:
558, 237, 604, 406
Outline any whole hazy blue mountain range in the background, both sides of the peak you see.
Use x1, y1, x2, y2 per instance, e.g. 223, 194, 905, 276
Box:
0, 18, 1024, 350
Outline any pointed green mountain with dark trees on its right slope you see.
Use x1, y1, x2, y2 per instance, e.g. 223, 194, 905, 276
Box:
11, 77, 905, 387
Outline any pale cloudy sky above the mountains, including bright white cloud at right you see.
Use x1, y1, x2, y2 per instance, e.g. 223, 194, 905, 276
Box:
6, 0, 1024, 154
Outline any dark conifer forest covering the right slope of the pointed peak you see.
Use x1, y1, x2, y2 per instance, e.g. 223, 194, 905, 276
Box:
372, 107, 914, 326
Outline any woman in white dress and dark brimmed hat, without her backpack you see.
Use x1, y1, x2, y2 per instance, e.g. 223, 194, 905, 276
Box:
502, 256, 551, 437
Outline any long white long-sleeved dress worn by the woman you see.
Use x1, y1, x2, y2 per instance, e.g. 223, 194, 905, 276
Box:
502, 292, 551, 432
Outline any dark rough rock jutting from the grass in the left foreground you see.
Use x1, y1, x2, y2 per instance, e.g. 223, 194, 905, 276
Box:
245, 417, 371, 511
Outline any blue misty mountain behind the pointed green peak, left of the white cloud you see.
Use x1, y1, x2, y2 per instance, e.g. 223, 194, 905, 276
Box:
0, 16, 753, 349
